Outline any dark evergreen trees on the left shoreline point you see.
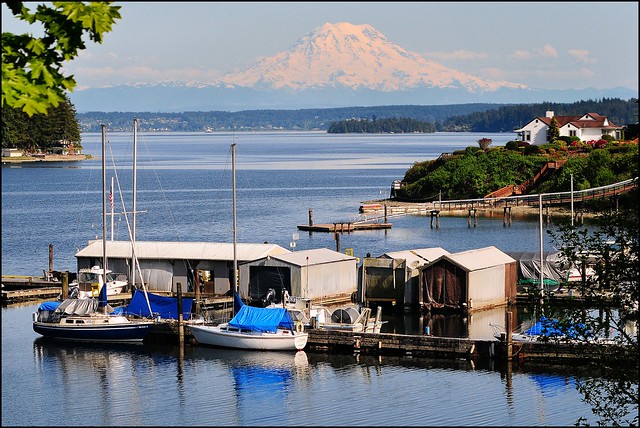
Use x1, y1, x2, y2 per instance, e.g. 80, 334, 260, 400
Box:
2, 95, 82, 153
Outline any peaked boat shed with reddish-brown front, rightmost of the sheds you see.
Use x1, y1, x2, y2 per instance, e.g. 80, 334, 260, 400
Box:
419, 246, 518, 312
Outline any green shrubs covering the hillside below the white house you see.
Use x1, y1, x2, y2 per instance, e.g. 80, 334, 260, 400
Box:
396, 140, 638, 202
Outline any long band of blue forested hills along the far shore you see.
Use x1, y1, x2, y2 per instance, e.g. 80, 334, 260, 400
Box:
77, 99, 638, 132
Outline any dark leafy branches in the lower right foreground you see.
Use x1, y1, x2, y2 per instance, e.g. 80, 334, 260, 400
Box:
544, 188, 640, 426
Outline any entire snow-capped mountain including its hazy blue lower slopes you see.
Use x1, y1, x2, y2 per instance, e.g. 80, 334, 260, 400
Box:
70, 22, 638, 113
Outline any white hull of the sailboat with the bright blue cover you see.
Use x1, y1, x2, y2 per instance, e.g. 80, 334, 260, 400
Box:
189, 324, 309, 351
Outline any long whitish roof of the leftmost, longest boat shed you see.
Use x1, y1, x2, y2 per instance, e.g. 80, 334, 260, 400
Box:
76, 240, 290, 261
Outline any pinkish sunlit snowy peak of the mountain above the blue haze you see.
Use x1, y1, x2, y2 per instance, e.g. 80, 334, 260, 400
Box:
221, 22, 526, 92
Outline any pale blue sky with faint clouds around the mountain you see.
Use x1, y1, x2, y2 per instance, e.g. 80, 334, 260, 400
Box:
2, 2, 639, 89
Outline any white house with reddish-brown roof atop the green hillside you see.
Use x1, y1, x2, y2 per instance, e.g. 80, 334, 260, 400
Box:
514, 111, 623, 146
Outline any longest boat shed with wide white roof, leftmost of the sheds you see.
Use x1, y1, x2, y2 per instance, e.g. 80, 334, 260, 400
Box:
75, 240, 290, 295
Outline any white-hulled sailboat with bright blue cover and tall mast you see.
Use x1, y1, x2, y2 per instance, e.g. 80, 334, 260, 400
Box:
189, 143, 309, 351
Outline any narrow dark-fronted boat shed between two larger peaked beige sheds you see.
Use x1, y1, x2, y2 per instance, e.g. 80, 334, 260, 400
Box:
359, 247, 449, 307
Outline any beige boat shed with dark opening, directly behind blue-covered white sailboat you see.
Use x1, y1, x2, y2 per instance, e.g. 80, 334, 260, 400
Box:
240, 248, 358, 302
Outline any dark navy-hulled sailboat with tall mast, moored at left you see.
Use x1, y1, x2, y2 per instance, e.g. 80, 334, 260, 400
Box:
33, 125, 154, 342
